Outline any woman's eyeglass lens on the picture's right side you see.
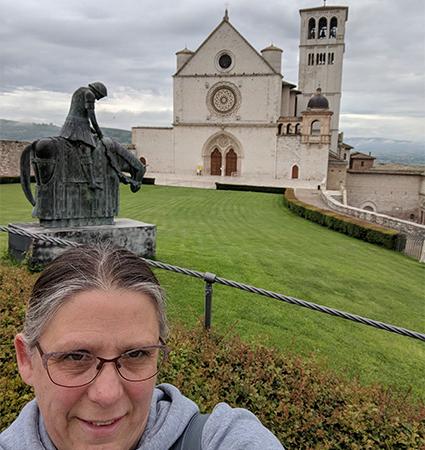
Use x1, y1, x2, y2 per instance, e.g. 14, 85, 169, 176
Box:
117, 348, 165, 381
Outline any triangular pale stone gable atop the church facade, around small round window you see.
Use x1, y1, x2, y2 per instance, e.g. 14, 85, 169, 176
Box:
175, 20, 277, 76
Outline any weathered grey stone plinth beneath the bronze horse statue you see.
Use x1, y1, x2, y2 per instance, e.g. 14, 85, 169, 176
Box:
8, 219, 156, 268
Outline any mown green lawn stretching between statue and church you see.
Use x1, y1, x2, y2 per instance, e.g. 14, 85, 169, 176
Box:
0, 185, 425, 397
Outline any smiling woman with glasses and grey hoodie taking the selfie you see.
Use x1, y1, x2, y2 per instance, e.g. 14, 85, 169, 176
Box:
0, 245, 283, 450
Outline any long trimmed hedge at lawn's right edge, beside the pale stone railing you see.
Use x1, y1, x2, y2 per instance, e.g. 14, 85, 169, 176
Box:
283, 189, 403, 250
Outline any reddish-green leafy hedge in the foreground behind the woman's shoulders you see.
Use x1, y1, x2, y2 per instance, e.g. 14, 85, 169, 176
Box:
0, 265, 425, 450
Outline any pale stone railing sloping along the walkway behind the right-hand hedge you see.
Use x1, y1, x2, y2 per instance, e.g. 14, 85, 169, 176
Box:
320, 190, 425, 239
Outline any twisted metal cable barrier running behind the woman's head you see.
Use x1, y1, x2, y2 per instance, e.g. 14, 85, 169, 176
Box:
0, 225, 425, 342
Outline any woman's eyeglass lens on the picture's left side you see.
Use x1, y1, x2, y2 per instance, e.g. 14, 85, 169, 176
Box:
47, 352, 97, 387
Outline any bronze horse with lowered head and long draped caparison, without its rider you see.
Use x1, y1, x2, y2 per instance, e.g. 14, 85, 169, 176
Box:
21, 137, 146, 228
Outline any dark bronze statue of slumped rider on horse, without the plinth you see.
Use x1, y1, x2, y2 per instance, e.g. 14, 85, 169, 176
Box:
21, 82, 145, 228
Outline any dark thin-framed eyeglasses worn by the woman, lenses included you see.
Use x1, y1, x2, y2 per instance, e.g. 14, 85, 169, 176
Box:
35, 339, 170, 387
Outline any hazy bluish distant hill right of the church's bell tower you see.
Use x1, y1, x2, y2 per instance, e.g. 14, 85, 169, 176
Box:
344, 137, 425, 164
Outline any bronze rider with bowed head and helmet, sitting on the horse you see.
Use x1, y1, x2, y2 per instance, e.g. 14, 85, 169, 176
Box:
59, 81, 108, 189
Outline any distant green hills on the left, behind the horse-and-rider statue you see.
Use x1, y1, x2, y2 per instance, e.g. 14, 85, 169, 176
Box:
0, 119, 131, 144
